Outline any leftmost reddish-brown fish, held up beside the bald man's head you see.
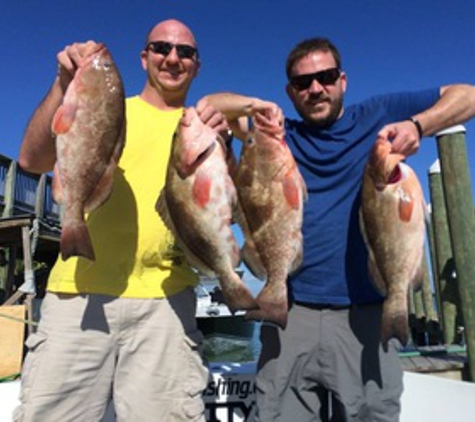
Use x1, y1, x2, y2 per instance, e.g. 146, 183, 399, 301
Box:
52, 44, 125, 261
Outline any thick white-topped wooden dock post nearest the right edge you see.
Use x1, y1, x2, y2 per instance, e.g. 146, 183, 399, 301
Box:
436, 126, 475, 382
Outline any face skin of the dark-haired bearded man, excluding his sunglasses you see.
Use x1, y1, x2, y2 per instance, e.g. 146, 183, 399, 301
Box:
286, 51, 346, 127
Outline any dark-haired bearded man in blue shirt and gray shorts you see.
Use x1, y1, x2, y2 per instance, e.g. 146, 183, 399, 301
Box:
205, 38, 475, 422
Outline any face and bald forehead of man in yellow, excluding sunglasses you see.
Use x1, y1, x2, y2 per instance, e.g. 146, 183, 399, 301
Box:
141, 22, 199, 98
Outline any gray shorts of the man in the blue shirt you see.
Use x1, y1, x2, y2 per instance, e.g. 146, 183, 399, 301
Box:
256, 304, 403, 422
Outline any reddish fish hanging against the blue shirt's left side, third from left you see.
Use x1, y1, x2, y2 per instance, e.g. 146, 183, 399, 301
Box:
234, 110, 307, 327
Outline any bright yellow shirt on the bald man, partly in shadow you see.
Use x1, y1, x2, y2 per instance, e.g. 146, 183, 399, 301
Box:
48, 96, 198, 298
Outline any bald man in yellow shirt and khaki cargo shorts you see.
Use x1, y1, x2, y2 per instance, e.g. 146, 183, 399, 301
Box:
14, 20, 229, 422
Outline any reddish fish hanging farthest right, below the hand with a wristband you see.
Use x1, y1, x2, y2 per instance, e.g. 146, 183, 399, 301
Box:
360, 138, 426, 345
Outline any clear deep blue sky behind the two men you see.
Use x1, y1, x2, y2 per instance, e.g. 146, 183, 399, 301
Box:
0, 0, 475, 203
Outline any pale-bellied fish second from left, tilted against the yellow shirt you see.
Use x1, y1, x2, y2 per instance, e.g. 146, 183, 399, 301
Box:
157, 107, 257, 312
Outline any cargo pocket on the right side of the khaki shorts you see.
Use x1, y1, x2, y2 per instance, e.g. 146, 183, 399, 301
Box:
184, 330, 209, 420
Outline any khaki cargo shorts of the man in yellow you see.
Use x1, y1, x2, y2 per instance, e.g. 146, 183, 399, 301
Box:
14, 289, 208, 422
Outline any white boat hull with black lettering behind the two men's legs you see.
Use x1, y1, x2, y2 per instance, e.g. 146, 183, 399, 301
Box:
0, 363, 475, 422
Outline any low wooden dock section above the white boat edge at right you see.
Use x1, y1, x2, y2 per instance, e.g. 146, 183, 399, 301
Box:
399, 346, 468, 380
